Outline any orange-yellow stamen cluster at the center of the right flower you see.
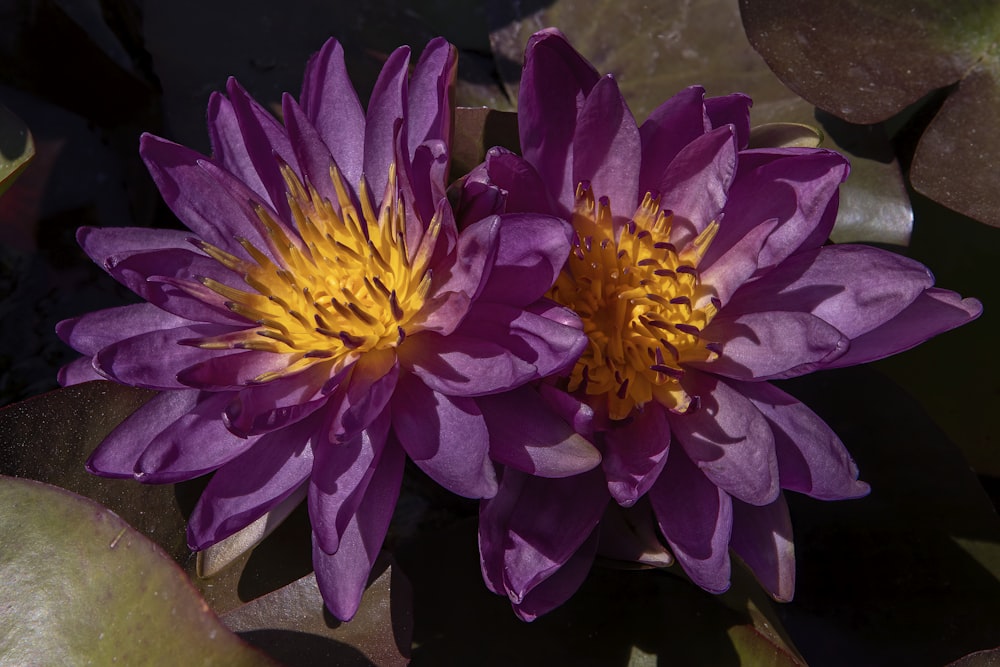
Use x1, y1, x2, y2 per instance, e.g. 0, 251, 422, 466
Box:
549, 182, 718, 419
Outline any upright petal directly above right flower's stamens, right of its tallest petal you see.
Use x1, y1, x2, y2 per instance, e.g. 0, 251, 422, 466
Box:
573, 75, 642, 207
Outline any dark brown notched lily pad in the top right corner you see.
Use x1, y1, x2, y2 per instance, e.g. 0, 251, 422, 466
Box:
740, 0, 1000, 226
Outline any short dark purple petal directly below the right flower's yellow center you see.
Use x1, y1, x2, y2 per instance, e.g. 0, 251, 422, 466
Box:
603, 402, 670, 507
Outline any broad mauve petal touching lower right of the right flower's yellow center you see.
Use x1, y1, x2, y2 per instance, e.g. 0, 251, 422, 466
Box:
661, 370, 780, 505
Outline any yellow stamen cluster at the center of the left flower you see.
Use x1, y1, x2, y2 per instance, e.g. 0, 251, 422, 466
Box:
193, 160, 441, 382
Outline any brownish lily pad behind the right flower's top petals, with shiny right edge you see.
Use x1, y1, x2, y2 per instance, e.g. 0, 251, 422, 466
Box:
490, 0, 913, 245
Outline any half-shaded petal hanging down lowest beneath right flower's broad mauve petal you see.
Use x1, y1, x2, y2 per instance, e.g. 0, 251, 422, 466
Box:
647, 447, 733, 593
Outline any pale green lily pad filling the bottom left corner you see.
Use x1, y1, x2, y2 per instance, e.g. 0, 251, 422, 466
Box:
0, 477, 277, 667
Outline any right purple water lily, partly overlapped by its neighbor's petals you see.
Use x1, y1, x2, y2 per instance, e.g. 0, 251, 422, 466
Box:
463, 30, 981, 620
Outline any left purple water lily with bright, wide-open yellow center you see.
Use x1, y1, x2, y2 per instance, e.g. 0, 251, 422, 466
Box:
58, 39, 599, 619
